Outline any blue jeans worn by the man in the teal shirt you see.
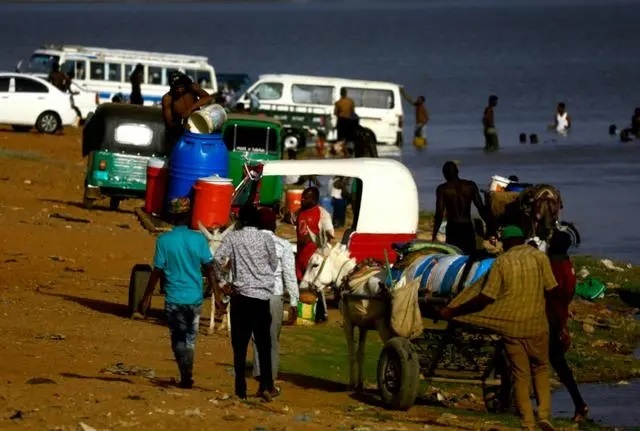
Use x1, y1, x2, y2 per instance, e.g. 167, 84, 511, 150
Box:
164, 302, 202, 382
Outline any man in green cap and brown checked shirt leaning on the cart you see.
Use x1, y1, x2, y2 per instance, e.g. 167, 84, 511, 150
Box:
440, 226, 557, 431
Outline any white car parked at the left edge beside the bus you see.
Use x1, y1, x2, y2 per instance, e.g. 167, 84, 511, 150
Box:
0, 73, 78, 133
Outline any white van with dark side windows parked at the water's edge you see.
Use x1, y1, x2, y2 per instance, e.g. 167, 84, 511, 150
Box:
237, 74, 404, 145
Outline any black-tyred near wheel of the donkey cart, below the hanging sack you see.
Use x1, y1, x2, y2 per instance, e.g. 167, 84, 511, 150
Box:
378, 337, 420, 410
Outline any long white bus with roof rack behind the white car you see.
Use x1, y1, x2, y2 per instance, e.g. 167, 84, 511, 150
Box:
16, 45, 217, 105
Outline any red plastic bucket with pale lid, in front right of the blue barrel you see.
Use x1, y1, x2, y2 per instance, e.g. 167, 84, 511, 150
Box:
191, 175, 235, 229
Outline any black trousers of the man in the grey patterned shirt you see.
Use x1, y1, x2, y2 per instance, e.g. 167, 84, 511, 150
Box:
231, 295, 273, 398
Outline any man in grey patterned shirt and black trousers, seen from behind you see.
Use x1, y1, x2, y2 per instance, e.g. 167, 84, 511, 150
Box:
215, 206, 279, 401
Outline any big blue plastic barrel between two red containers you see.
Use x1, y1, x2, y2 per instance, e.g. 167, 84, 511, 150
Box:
167, 132, 229, 206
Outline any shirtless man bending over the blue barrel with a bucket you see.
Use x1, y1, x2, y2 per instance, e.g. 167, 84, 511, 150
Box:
162, 72, 213, 139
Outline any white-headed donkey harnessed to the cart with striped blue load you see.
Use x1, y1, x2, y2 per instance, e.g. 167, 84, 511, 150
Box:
300, 244, 392, 391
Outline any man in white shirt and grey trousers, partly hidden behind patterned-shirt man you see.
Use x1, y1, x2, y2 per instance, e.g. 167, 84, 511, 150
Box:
253, 208, 300, 380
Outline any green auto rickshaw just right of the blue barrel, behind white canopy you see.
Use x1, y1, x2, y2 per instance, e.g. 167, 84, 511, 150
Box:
222, 114, 283, 207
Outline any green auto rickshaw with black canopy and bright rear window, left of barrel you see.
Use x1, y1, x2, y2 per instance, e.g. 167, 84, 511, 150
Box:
82, 103, 172, 210
